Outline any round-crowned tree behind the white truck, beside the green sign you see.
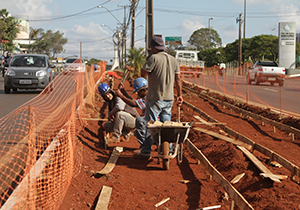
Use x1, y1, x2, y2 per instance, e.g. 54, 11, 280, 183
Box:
188, 28, 222, 51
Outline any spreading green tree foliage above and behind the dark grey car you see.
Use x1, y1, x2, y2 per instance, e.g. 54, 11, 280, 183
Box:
21, 28, 68, 58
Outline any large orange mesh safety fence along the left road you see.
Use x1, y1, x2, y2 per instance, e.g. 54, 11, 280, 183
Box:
0, 61, 106, 209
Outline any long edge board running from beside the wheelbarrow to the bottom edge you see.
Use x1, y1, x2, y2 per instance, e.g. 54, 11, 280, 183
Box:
184, 139, 253, 210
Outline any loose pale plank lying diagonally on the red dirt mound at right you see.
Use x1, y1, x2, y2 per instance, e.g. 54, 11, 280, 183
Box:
238, 146, 285, 182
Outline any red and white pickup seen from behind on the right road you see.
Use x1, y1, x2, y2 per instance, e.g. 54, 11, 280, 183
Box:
247, 60, 285, 87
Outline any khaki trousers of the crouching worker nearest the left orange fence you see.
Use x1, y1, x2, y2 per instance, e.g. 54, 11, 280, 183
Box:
104, 111, 135, 138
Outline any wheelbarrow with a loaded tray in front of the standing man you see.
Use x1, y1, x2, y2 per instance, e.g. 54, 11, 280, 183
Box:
147, 121, 193, 170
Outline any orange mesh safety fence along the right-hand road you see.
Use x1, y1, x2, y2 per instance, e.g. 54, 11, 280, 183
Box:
181, 63, 300, 116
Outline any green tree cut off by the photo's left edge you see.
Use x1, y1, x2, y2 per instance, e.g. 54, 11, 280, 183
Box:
0, 9, 19, 52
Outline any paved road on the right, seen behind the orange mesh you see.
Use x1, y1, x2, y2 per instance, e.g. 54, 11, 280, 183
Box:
187, 75, 300, 114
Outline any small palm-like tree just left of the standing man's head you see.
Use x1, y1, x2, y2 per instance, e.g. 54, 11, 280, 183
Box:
127, 47, 146, 79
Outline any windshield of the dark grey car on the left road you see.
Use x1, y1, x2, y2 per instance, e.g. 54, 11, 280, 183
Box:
10, 55, 46, 67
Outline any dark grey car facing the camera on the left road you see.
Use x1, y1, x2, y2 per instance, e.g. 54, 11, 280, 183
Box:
4, 54, 55, 93
